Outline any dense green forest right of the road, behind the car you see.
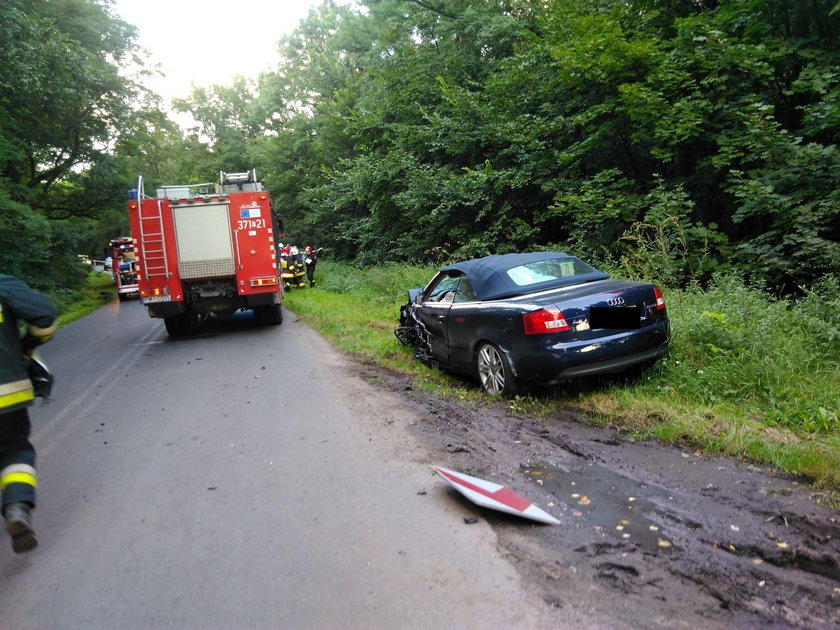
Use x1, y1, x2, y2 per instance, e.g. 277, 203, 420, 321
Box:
220, 0, 840, 287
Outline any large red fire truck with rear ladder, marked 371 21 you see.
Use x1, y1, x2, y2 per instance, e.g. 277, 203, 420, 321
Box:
128, 170, 283, 336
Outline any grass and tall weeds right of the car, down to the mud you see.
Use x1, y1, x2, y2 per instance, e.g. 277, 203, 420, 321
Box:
580, 277, 840, 489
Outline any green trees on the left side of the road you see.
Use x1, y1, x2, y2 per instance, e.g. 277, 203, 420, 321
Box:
0, 0, 143, 289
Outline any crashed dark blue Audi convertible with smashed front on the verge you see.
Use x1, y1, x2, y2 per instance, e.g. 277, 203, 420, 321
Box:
396, 252, 670, 396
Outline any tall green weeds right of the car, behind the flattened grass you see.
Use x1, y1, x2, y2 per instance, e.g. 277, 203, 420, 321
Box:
659, 276, 840, 433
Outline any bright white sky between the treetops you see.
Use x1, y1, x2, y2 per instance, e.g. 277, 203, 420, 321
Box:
112, 0, 321, 105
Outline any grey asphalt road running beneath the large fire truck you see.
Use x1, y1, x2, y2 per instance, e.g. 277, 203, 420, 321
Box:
0, 301, 564, 630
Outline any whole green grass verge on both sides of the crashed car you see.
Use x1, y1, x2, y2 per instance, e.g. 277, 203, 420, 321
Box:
286, 261, 840, 494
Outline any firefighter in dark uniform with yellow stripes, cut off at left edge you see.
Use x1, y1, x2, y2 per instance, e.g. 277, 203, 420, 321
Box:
0, 274, 57, 553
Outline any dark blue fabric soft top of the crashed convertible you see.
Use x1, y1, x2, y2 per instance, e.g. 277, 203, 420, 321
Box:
441, 252, 610, 300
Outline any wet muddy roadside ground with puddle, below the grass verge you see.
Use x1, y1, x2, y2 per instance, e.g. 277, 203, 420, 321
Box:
360, 366, 840, 628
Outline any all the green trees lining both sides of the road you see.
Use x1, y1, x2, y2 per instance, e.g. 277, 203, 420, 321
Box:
0, 0, 840, 289
